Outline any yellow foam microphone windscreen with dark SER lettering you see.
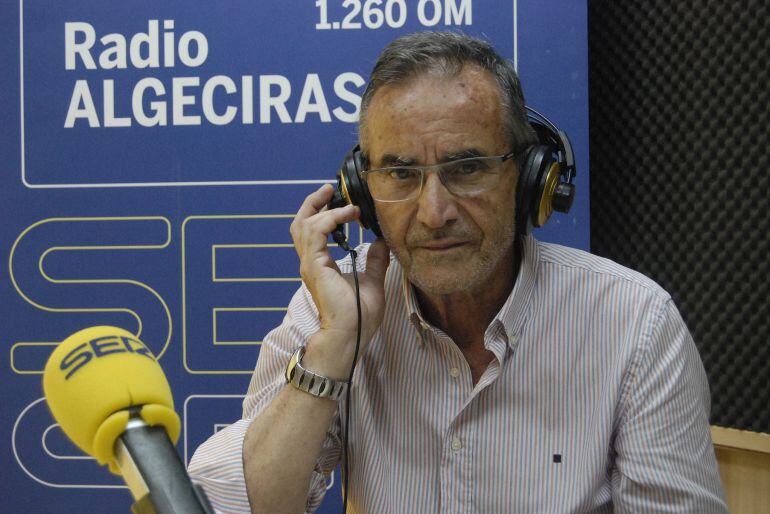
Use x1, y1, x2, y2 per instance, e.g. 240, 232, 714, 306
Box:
43, 326, 178, 462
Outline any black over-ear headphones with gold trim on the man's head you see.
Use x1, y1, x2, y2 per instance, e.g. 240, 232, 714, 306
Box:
329, 107, 577, 242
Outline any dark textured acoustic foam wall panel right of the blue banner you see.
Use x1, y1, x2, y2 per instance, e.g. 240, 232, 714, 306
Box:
589, 0, 770, 432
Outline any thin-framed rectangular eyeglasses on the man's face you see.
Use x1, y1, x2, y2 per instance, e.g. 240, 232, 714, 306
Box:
361, 152, 514, 202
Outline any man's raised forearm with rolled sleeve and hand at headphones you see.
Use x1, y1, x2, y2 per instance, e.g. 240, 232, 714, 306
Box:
191, 185, 389, 514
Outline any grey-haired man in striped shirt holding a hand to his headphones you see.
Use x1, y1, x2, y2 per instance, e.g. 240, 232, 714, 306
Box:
190, 33, 726, 514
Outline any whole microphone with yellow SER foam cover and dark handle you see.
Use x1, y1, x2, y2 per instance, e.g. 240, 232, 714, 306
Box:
43, 326, 213, 514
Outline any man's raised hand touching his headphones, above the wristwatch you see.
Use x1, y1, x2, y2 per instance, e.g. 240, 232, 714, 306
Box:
291, 184, 390, 379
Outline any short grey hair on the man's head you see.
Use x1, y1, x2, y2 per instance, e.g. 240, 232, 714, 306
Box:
359, 32, 537, 153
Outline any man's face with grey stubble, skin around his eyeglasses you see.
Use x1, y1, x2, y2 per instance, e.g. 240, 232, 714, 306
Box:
365, 65, 517, 295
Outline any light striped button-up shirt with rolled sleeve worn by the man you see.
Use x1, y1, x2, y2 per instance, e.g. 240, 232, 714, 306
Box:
190, 237, 727, 514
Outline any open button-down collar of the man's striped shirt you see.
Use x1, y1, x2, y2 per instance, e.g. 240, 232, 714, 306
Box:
401, 236, 539, 349
